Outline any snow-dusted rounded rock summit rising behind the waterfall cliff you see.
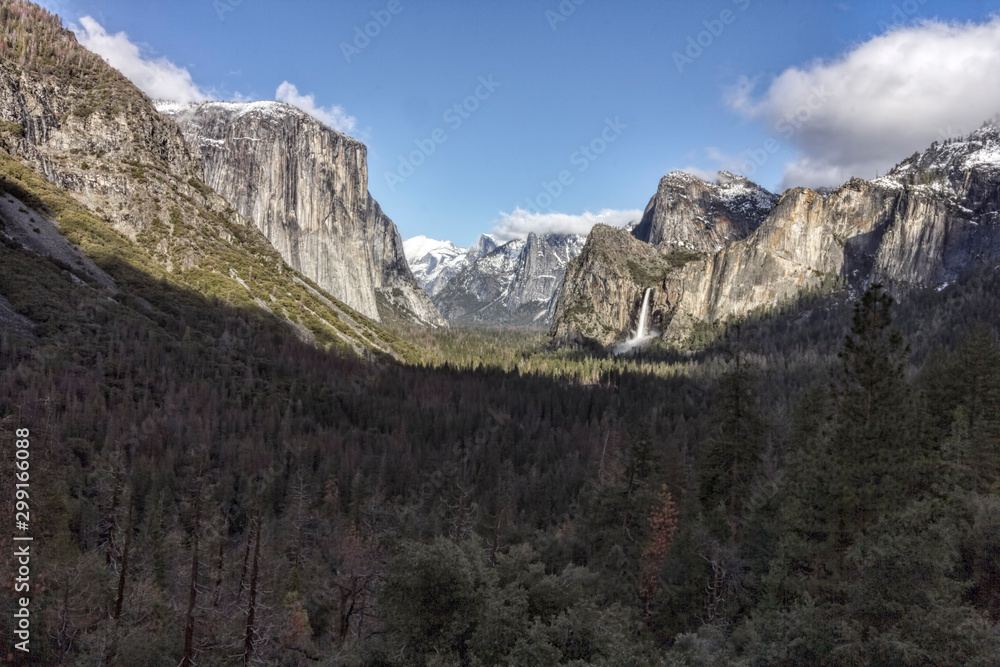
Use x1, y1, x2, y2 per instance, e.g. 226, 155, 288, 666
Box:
632, 171, 778, 253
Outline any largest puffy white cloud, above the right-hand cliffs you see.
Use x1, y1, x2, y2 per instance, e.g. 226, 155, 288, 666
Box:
726, 16, 1000, 187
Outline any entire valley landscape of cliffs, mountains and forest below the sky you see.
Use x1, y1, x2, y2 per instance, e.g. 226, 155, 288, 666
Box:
0, 0, 1000, 667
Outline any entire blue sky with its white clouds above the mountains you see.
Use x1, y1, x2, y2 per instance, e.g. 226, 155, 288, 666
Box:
35, 0, 1000, 245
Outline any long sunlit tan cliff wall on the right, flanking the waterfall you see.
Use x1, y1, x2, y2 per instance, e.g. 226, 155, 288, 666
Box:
552, 126, 1000, 345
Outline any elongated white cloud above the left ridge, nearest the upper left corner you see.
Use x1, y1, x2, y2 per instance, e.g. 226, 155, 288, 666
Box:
70, 16, 207, 102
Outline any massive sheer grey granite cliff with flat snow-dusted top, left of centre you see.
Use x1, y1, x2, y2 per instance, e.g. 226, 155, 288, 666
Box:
160, 102, 444, 325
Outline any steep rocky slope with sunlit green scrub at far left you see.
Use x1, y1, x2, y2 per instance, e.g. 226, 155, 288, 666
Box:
0, 2, 419, 359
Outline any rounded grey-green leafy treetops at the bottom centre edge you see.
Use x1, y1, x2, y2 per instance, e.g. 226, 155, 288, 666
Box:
381, 538, 657, 665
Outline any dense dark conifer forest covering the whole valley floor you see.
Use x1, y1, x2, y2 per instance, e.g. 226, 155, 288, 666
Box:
0, 155, 1000, 666
